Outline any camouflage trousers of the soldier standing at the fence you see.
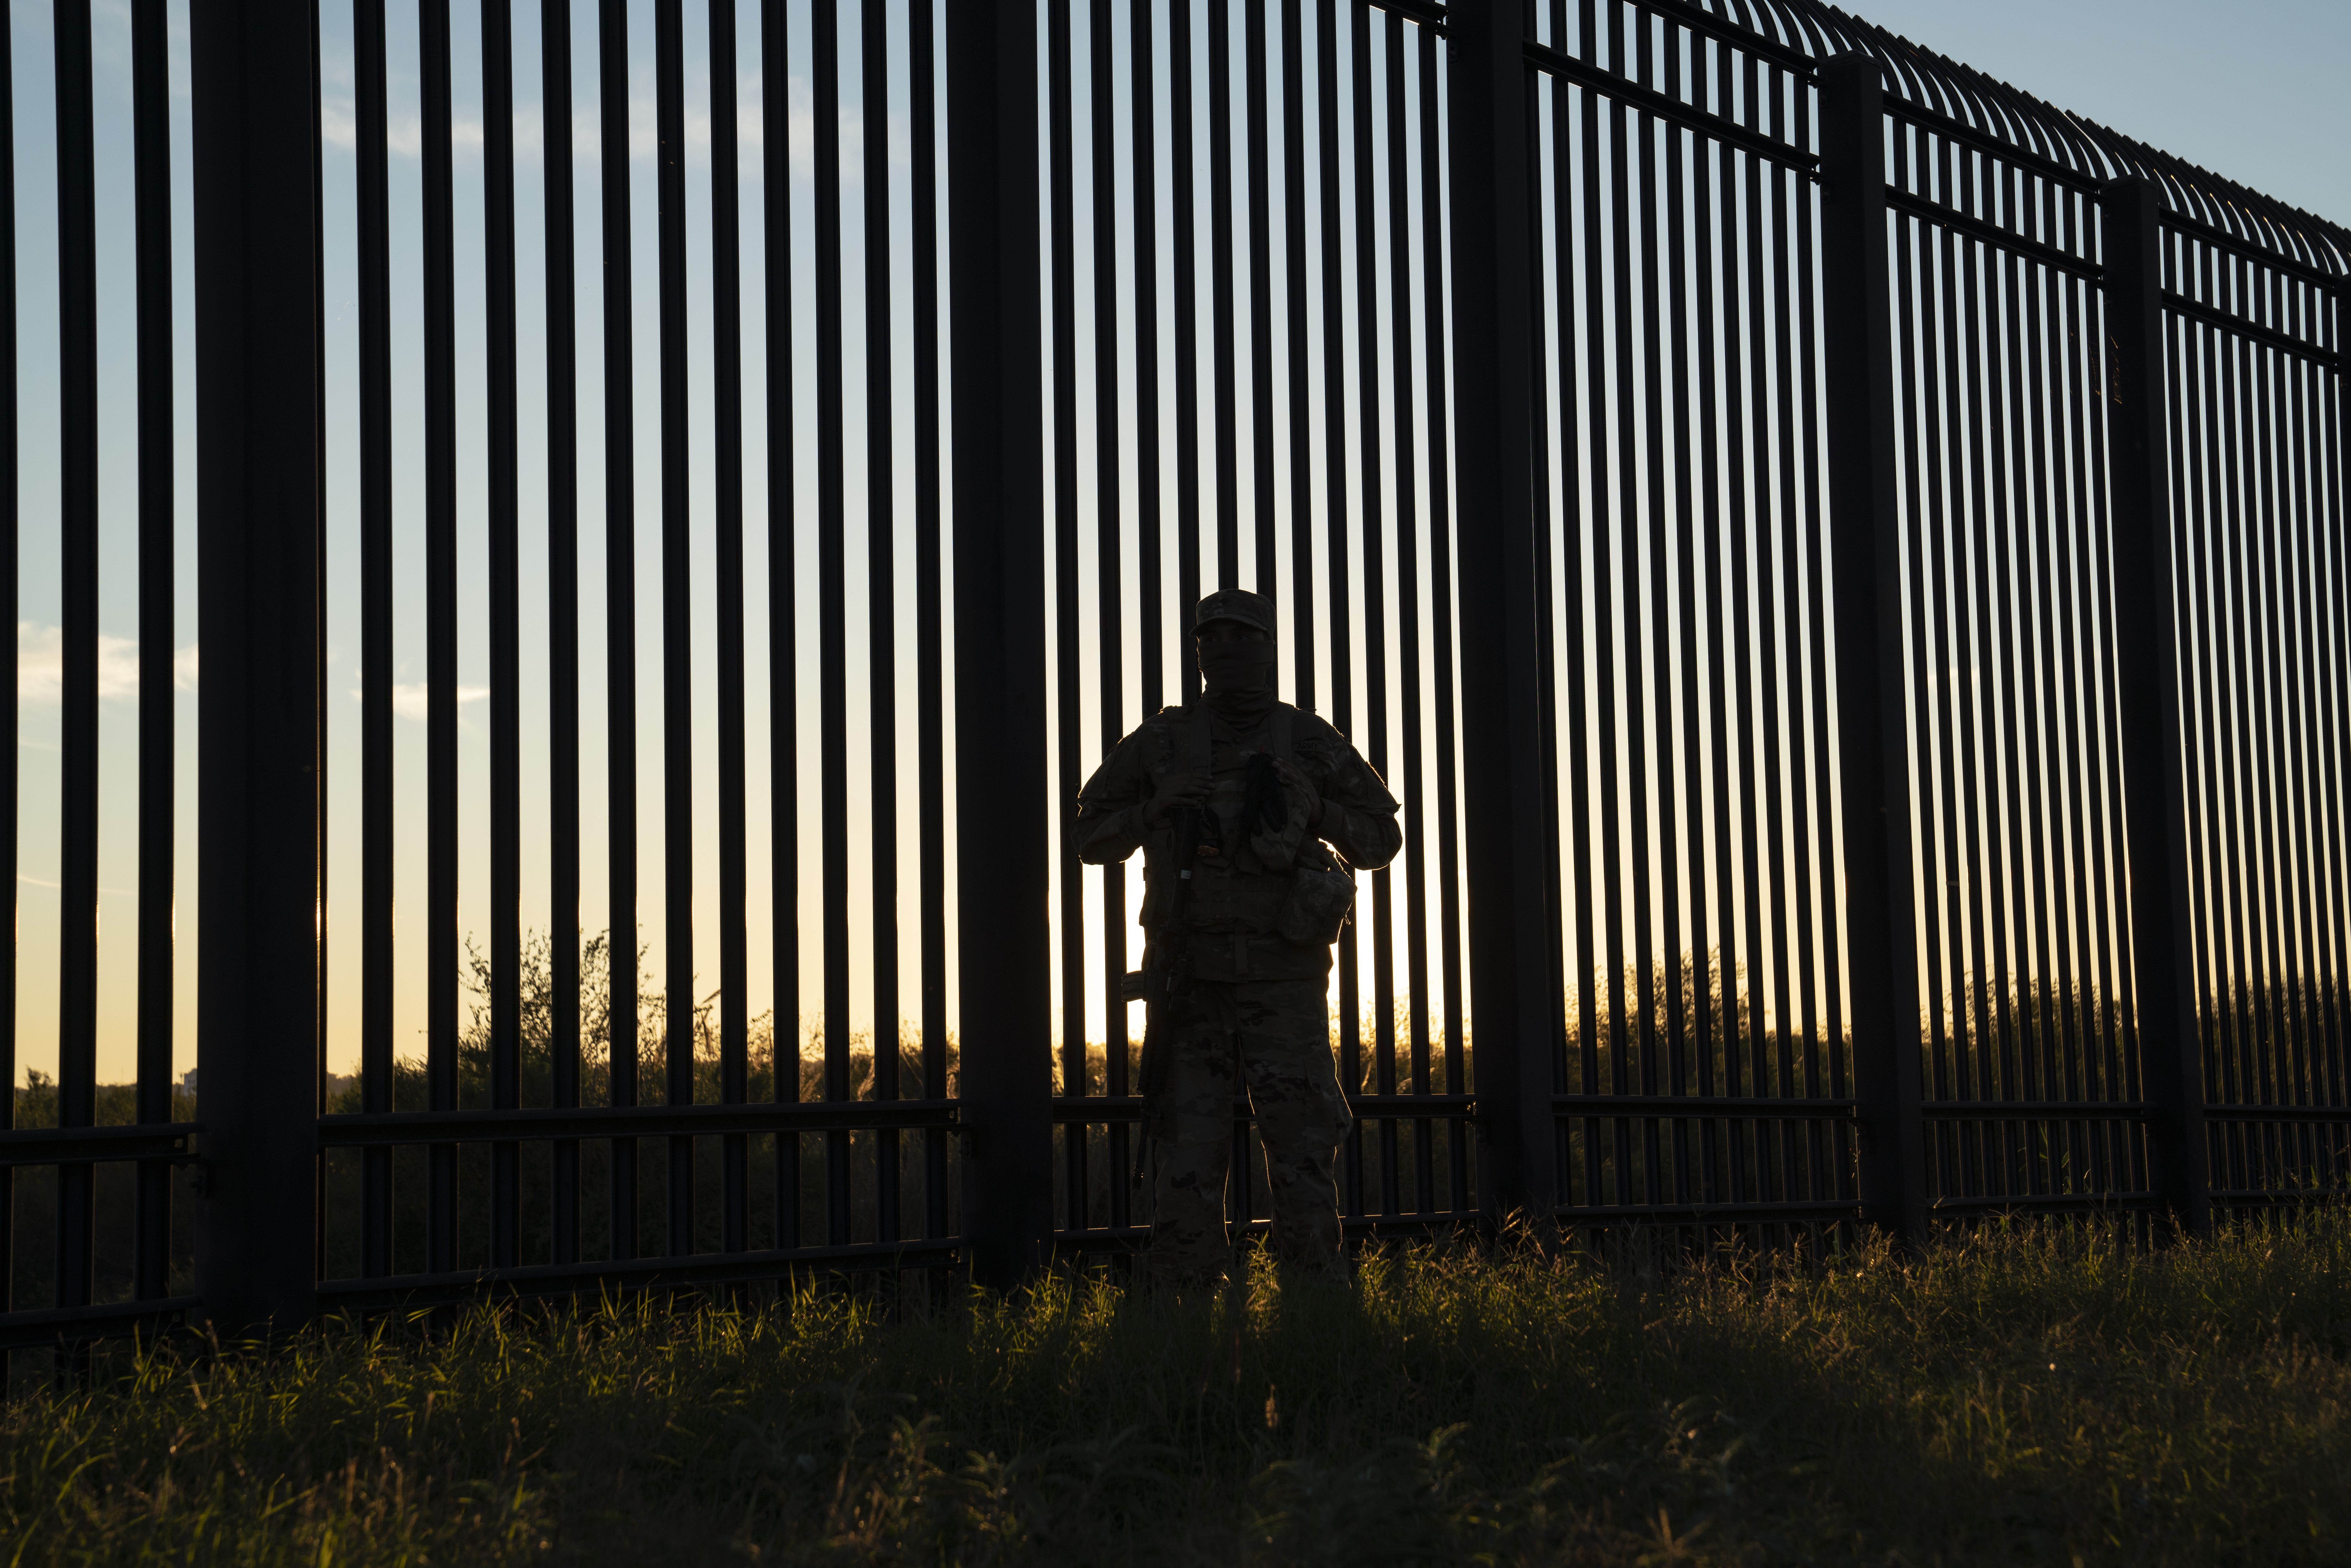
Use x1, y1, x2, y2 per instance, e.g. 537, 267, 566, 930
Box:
1147, 978, 1354, 1279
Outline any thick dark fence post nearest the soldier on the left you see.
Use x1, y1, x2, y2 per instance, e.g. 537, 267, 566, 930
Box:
947, 0, 1053, 1288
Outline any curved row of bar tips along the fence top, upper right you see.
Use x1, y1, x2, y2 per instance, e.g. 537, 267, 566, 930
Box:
1657, 0, 2351, 280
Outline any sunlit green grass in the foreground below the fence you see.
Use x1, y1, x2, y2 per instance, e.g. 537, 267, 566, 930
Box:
0, 1215, 2351, 1566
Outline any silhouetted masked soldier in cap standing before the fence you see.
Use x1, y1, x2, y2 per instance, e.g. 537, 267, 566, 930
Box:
1074, 588, 1401, 1281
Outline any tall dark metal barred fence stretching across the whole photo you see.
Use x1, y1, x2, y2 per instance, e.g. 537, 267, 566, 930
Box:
0, 0, 2351, 1366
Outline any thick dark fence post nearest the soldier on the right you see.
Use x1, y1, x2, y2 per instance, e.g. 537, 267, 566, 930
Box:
1446, 0, 1561, 1223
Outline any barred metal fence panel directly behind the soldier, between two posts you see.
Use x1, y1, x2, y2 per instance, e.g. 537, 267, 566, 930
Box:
1039, 0, 1474, 1251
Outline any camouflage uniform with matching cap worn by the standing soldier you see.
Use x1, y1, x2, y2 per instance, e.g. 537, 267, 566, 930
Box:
1074, 590, 1401, 1279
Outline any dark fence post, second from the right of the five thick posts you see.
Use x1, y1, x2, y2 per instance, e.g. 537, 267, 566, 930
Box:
1820, 54, 1926, 1246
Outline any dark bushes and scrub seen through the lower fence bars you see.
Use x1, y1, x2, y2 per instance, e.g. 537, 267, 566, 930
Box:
9, 933, 2342, 1307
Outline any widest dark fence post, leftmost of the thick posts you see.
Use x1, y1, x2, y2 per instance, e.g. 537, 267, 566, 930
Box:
188, 0, 324, 1335
